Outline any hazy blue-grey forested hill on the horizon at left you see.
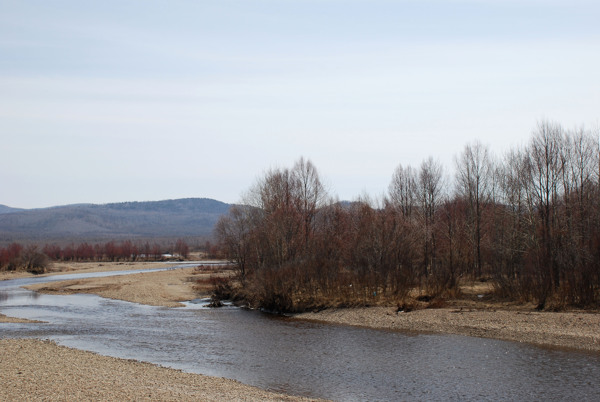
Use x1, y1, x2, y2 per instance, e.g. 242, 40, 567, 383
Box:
0, 198, 230, 242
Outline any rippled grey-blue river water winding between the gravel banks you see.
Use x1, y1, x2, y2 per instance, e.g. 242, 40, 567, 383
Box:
0, 266, 600, 401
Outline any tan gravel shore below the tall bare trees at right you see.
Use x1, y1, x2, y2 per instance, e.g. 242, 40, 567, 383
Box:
295, 307, 600, 352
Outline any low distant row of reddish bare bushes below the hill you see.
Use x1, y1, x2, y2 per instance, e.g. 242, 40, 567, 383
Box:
0, 239, 217, 273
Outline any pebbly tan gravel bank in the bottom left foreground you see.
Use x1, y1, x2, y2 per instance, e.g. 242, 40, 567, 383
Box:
0, 339, 318, 401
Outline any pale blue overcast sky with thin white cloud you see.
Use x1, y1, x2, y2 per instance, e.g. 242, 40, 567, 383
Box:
0, 0, 600, 208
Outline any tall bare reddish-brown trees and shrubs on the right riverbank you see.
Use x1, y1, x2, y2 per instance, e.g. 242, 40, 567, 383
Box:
216, 121, 600, 311
